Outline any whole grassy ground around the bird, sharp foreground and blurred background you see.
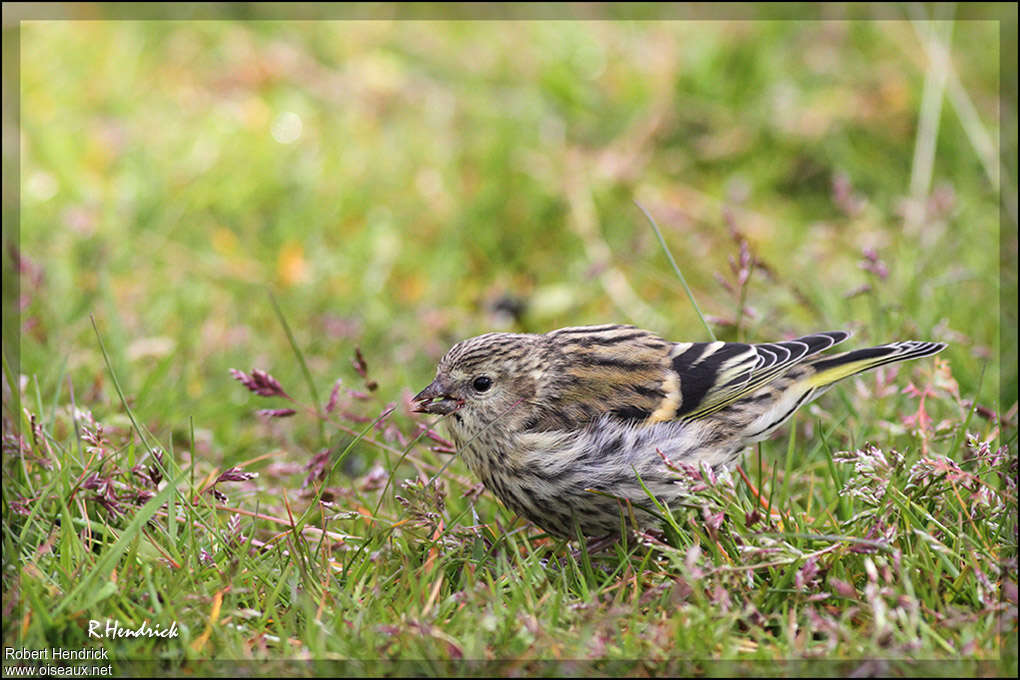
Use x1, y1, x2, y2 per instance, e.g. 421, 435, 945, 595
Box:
3, 6, 1017, 676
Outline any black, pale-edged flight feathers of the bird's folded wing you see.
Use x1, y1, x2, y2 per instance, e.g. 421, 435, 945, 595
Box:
661, 330, 850, 420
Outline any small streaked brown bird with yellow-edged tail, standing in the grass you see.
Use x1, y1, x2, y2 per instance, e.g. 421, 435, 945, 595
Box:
414, 324, 946, 537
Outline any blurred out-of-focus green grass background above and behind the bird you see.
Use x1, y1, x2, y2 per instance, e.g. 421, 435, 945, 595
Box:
9, 6, 1016, 468
